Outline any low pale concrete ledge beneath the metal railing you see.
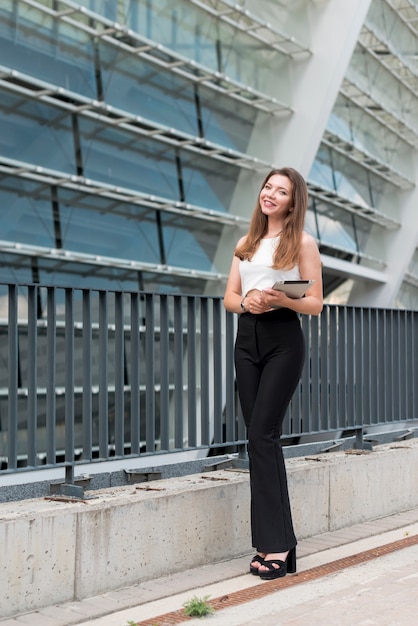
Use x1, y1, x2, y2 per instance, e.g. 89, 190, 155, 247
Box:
0, 440, 418, 617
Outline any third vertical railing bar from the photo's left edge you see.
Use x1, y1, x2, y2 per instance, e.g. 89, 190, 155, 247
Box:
46, 287, 57, 464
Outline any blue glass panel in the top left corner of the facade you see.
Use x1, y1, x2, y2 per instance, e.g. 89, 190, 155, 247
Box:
0, 3, 96, 98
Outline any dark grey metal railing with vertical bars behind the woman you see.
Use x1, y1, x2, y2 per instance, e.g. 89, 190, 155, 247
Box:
0, 284, 418, 473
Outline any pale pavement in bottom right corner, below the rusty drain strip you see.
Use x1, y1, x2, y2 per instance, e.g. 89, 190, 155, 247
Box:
179, 545, 418, 626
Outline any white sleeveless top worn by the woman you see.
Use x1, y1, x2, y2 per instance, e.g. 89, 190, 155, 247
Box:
239, 237, 301, 296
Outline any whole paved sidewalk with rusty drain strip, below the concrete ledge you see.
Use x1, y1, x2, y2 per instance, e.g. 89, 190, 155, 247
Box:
0, 509, 418, 626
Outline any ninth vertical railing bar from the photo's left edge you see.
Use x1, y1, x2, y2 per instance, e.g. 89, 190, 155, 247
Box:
145, 294, 155, 452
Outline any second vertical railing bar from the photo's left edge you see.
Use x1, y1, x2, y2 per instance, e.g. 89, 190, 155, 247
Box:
27, 286, 38, 467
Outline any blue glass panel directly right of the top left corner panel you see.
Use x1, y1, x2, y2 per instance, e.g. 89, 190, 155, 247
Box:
100, 44, 198, 135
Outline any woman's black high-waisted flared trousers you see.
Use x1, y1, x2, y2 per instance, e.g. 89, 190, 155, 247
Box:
235, 309, 305, 553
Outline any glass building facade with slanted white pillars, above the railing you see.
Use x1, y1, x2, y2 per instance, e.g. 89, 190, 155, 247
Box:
0, 0, 418, 308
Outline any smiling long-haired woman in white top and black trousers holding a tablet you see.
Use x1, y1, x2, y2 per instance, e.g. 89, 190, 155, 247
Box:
224, 168, 323, 579
